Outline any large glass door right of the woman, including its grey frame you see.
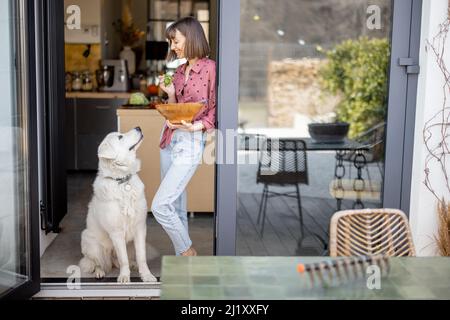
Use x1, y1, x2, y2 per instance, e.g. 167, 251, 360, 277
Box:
217, 0, 421, 256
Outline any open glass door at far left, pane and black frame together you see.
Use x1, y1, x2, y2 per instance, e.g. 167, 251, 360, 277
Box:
0, 0, 39, 297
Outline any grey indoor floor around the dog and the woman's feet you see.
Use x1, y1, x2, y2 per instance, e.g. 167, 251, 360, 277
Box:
41, 173, 213, 278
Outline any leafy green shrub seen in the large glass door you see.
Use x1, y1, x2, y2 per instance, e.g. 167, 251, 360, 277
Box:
319, 37, 390, 137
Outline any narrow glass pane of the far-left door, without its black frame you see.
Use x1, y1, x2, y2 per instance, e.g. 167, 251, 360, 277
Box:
0, 0, 30, 296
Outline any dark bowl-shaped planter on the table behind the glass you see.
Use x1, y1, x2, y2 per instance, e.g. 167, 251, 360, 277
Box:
308, 122, 350, 143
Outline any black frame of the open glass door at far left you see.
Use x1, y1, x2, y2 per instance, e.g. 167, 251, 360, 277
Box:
0, 0, 41, 300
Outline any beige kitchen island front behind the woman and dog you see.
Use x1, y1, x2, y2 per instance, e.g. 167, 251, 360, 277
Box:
117, 108, 215, 212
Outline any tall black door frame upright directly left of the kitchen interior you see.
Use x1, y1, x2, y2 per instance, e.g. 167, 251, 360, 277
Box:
35, 0, 67, 234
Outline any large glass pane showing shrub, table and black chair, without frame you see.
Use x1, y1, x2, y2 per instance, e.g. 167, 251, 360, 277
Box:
236, 0, 392, 256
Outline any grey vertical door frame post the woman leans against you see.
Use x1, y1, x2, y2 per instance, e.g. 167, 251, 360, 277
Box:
214, 0, 241, 256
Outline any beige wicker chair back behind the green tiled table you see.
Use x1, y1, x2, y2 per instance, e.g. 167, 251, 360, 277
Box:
330, 209, 415, 257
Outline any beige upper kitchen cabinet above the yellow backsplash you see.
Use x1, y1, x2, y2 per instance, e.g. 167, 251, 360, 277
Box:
64, 0, 102, 44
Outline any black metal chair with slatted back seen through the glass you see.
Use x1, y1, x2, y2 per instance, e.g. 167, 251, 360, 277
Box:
256, 138, 308, 236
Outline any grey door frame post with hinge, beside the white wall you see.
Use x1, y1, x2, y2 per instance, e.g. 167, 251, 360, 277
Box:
383, 0, 422, 212
